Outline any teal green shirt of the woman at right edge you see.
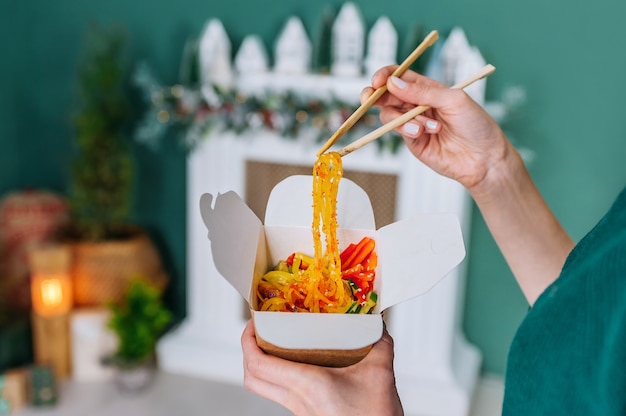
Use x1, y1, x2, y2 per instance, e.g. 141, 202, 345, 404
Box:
502, 188, 626, 416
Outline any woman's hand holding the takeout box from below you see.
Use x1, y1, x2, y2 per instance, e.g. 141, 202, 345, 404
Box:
241, 320, 403, 416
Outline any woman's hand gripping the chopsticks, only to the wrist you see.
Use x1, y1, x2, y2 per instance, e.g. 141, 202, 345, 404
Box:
361, 66, 516, 195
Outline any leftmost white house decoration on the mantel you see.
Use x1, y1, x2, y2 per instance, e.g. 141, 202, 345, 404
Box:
198, 19, 233, 89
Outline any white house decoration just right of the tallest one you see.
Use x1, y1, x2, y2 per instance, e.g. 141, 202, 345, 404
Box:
365, 16, 398, 78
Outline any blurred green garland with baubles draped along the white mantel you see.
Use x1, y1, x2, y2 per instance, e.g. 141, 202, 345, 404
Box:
134, 63, 402, 153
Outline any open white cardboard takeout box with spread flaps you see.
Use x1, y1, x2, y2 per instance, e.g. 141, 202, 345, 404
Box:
200, 175, 465, 367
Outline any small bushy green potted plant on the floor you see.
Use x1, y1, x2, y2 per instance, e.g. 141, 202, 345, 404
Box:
107, 279, 172, 393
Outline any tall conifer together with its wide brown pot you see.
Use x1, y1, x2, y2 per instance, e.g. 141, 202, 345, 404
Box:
69, 26, 167, 306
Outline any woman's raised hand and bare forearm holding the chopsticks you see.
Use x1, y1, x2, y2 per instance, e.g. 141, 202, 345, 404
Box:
361, 66, 574, 305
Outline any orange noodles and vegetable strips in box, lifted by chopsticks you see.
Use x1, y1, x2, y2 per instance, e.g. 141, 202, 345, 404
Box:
257, 152, 376, 313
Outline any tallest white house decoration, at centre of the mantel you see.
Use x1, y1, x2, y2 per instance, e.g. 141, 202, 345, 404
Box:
330, 3, 365, 77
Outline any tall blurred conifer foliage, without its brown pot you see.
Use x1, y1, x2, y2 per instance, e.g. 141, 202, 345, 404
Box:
71, 27, 133, 241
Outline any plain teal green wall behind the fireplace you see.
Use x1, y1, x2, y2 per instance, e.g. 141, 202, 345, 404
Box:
0, 0, 626, 374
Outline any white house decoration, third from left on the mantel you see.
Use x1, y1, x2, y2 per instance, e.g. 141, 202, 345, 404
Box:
274, 16, 312, 74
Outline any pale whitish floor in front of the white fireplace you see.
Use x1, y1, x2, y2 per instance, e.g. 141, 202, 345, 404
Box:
11, 372, 503, 416
